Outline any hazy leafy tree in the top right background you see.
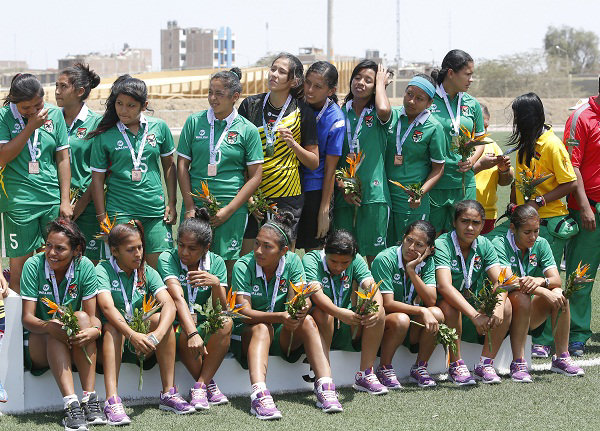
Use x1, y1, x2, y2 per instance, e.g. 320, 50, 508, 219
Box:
544, 26, 600, 74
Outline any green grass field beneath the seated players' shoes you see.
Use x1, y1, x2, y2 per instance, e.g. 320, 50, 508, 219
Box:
0, 133, 600, 431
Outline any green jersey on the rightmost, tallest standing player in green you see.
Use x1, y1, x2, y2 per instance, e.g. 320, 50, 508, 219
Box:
429, 86, 485, 190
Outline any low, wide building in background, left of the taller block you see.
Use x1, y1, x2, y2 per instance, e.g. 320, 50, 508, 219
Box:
58, 44, 152, 77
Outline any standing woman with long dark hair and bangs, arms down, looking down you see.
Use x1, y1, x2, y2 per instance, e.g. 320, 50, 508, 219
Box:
88, 75, 177, 268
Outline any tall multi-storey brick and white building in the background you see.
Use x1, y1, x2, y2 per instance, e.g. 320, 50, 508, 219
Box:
160, 21, 235, 70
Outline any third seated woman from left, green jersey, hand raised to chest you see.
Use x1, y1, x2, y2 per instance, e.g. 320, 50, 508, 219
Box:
158, 208, 232, 410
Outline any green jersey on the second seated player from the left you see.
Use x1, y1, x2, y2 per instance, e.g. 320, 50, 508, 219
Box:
96, 256, 167, 317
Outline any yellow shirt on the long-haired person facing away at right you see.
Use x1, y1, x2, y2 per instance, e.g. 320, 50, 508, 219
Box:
516, 129, 577, 218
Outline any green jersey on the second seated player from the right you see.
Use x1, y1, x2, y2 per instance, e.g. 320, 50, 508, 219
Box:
434, 231, 499, 292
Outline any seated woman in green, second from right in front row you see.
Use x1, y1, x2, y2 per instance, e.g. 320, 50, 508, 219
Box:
434, 200, 511, 385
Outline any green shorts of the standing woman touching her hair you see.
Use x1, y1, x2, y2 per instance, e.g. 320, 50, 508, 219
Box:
333, 203, 390, 256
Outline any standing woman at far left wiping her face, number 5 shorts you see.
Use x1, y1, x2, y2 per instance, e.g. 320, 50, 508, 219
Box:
0, 73, 73, 293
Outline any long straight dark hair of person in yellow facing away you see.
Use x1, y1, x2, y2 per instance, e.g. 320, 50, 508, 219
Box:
508, 93, 546, 166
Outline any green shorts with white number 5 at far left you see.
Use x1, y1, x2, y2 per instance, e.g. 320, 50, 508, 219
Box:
4, 205, 60, 257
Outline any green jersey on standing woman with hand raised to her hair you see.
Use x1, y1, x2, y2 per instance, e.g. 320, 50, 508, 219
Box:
335, 102, 397, 207
